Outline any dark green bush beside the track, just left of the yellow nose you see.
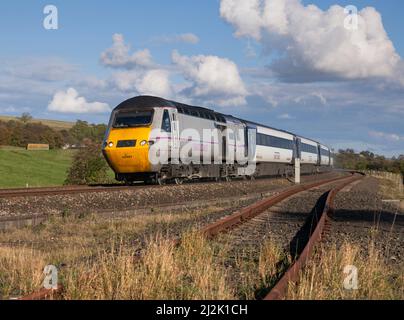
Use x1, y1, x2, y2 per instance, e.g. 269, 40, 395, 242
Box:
65, 140, 108, 185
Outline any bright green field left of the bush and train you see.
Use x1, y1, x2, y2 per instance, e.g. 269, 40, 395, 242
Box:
0, 147, 76, 188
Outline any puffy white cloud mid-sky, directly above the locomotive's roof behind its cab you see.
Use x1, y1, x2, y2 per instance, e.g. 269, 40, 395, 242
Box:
172, 51, 248, 106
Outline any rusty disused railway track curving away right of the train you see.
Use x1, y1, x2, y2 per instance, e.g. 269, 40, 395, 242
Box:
197, 175, 362, 300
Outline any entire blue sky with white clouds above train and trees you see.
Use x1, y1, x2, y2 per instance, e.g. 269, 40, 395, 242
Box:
0, 0, 404, 156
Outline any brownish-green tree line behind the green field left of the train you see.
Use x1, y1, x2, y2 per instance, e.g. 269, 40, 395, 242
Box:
0, 117, 107, 149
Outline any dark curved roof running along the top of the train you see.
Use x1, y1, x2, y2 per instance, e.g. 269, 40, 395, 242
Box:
114, 96, 330, 149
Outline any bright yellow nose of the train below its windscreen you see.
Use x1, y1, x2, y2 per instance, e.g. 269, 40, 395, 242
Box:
103, 127, 151, 173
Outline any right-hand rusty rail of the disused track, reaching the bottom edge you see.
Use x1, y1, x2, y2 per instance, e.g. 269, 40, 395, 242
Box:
264, 172, 363, 300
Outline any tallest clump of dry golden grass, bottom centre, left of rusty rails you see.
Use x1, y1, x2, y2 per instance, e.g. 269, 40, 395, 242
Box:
60, 233, 233, 299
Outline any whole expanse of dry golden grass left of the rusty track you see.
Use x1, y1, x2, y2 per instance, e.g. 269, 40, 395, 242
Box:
0, 208, 234, 299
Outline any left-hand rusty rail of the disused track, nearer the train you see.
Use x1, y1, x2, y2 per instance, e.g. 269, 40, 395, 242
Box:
200, 173, 353, 238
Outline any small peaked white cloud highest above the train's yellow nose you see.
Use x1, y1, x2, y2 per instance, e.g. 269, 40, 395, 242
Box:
100, 33, 153, 69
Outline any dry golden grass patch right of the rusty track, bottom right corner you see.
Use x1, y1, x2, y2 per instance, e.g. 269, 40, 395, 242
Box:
286, 243, 404, 300
